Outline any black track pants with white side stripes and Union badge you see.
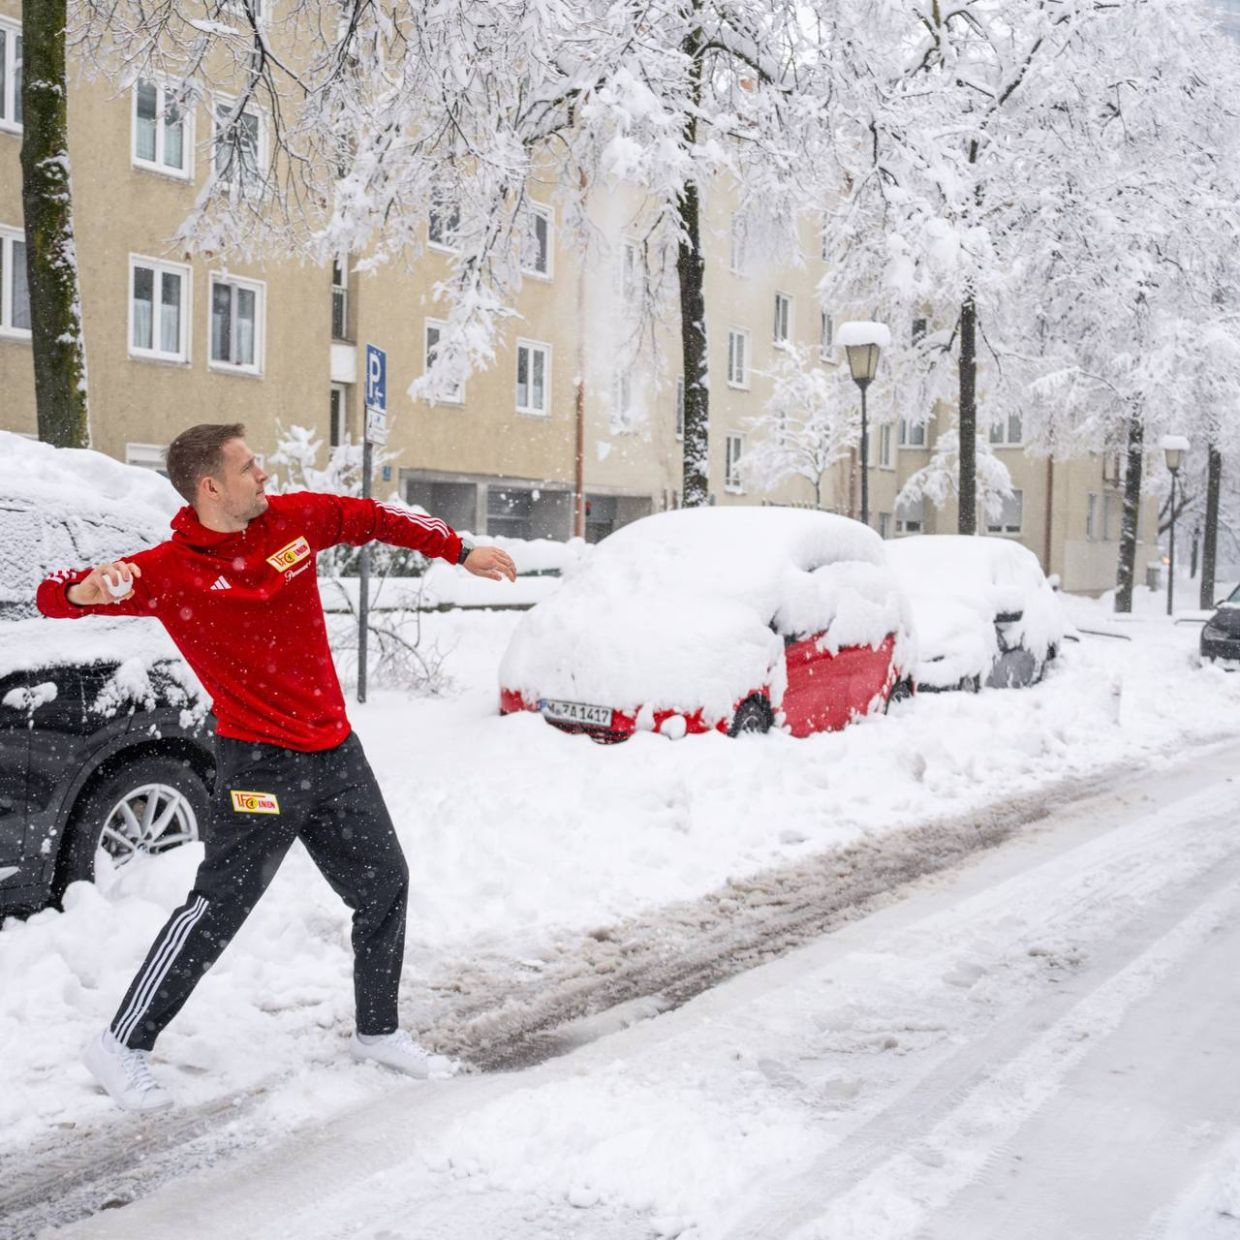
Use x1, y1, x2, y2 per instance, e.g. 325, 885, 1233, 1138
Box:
112, 735, 409, 1050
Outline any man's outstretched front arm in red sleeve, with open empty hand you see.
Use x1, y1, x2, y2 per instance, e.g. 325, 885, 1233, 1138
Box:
288, 491, 517, 582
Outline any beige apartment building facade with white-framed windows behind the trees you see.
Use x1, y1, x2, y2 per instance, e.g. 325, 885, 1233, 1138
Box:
0, 0, 1148, 591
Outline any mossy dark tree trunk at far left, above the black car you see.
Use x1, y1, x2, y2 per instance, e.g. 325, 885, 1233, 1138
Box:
21, 0, 91, 448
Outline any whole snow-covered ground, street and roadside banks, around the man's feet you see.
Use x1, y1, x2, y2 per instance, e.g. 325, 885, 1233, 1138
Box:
0, 596, 1240, 1240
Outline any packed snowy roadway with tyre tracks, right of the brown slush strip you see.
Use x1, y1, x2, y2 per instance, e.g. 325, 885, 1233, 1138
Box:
29, 742, 1240, 1240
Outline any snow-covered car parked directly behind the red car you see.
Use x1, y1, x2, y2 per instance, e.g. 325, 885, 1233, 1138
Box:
887, 534, 1064, 692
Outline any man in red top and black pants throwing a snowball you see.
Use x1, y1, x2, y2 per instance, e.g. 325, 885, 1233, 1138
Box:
37, 424, 516, 1111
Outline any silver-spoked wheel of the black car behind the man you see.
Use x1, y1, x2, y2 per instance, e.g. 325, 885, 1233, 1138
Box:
52, 755, 211, 899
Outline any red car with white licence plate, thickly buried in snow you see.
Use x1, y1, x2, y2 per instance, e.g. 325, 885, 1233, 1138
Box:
500, 508, 911, 740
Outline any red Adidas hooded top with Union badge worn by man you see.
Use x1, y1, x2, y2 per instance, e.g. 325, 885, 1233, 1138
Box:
37, 492, 461, 751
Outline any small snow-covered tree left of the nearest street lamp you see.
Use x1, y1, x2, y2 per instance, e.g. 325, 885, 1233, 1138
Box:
740, 347, 861, 508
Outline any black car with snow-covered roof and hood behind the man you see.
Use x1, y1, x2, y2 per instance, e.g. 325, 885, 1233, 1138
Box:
0, 432, 215, 916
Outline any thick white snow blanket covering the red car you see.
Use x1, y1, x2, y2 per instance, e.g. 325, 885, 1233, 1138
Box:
500, 508, 906, 722
